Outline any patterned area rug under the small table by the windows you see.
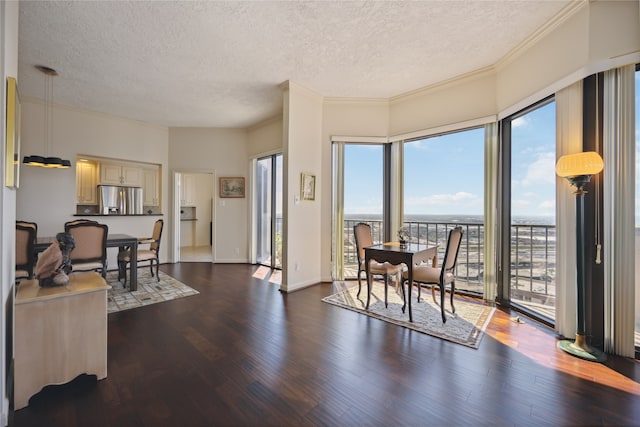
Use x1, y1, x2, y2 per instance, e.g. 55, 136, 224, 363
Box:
322, 281, 495, 349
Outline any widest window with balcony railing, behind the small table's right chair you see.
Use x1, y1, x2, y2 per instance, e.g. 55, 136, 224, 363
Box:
403, 127, 484, 293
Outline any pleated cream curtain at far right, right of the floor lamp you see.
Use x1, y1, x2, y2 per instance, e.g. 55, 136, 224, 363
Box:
603, 65, 635, 357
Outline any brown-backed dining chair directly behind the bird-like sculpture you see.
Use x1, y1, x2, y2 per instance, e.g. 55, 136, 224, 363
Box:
64, 220, 109, 277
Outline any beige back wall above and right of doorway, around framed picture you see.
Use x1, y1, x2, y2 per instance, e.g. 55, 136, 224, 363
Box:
169, 128, 249, 263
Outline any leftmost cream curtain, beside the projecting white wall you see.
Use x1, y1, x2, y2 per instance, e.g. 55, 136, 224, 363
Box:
331, 142, 344, 280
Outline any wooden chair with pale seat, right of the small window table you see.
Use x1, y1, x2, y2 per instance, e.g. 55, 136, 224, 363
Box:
403, 226, 464, 323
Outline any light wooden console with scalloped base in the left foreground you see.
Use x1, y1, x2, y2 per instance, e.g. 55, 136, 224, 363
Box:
13, 273, 111, 410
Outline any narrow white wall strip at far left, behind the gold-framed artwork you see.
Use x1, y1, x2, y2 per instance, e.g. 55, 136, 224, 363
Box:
0, 0, 19, 425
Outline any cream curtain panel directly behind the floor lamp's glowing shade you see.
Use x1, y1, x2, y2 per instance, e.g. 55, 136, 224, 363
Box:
555, 81, 583, 338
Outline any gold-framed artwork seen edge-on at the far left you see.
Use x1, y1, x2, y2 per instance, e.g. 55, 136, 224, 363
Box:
4, 77, 20, 188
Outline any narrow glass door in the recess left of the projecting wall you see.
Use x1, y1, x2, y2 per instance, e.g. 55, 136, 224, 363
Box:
255, 154, 282, 268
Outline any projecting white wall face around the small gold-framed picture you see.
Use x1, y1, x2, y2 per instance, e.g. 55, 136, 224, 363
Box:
281, 82, 325, 292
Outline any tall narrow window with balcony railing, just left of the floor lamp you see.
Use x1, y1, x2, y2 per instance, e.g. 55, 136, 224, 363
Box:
505, 99, 556, 322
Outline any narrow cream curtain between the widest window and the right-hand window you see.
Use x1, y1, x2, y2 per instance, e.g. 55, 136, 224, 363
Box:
483, 122, 499, 301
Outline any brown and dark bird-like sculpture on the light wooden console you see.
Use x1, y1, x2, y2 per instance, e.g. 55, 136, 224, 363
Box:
36, 233, 76, 287
